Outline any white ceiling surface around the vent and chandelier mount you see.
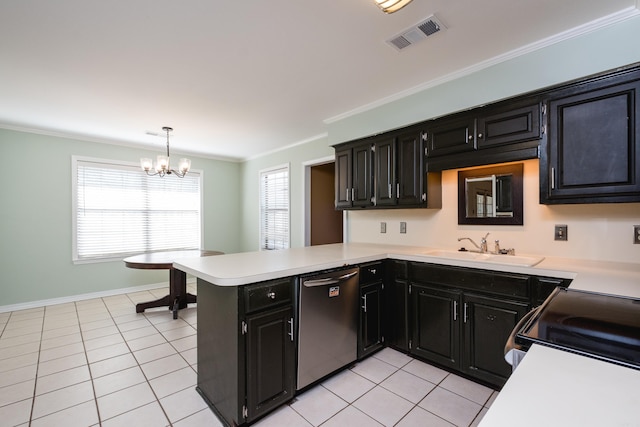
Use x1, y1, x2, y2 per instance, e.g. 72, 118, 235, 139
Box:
0, 0, 637, 159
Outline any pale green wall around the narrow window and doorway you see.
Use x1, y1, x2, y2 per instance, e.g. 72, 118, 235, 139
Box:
242, 137, 334, 252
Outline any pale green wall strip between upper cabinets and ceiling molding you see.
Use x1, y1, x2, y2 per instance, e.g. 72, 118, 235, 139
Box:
327, 16, 640, 144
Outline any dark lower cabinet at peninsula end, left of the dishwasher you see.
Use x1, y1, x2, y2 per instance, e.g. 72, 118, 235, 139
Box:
197, 277, 296, 425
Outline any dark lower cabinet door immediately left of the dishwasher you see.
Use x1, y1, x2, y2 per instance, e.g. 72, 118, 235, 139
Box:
245, 306, 295, 421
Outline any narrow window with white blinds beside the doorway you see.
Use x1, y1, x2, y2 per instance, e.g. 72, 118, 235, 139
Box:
260, 165, 289, 250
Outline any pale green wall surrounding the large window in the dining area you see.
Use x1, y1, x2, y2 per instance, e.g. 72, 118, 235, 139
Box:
0, 129, 241, 307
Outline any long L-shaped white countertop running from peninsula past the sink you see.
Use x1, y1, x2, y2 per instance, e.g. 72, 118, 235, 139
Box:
174, 243, 640, 298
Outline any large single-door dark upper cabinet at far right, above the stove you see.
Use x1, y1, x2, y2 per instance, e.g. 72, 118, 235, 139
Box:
540, 68, 640, 204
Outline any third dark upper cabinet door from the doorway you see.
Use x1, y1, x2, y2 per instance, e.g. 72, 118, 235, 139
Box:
373, 136, 397, 206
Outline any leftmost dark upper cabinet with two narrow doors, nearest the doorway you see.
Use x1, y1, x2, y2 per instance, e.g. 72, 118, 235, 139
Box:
335, 142, 373, 209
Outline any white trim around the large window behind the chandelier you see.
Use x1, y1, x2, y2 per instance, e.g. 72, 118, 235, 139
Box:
71, 155, 205, 264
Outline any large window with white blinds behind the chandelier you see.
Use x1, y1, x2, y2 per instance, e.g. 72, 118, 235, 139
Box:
72, 157, 202, 262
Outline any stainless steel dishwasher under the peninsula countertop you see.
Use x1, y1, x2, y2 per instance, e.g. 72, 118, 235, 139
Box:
297, 267, 359, 390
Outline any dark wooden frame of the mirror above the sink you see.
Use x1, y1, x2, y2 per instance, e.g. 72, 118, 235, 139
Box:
458, 163, 523, 225
